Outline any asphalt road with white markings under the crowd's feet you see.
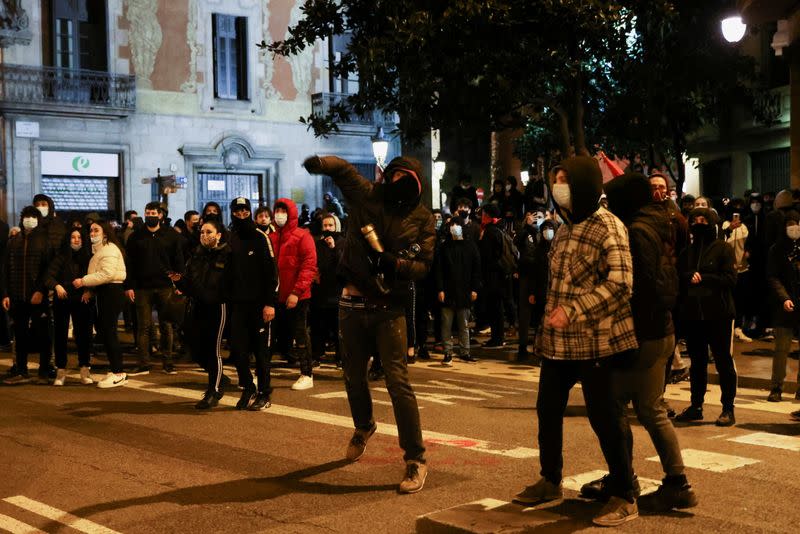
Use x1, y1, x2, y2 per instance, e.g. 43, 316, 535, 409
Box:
0, 353, 800, 533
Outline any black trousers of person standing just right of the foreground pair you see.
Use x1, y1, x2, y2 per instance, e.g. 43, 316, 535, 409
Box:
684, 319, 738, 410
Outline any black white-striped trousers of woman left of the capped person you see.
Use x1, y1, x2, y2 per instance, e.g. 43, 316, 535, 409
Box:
186, 301, 227, 392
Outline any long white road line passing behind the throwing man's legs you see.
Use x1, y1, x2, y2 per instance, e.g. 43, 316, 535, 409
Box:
126, 380, 539, 459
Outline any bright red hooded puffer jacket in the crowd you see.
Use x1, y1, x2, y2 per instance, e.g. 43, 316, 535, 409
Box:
269, 198, 317, 304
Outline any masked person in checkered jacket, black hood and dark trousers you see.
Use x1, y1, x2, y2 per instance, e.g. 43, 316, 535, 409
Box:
514, 156, 639, 526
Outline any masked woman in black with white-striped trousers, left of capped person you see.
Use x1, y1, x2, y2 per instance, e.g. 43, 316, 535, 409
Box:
170, 220, 231, 410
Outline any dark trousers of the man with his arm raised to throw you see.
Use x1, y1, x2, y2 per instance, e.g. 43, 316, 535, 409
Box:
339, 300, 425, 462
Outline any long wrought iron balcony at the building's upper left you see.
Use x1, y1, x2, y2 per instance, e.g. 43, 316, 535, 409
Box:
0, 64, 136, 118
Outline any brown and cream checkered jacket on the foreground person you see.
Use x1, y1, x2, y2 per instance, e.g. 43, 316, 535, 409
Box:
536, 208, 638, 360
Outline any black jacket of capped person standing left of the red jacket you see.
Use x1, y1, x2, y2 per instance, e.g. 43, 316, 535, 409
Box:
226, 225, 278, 307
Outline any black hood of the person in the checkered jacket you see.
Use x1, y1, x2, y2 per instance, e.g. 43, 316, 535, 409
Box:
550, 156, 603, 224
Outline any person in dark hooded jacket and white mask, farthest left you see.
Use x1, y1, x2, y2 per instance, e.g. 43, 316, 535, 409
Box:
0, 206, 51, 385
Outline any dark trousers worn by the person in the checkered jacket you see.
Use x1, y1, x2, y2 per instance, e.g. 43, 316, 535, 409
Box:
536, 355, 633, 501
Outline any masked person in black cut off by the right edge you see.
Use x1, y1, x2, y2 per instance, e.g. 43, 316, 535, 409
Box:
767, 211, 800, 402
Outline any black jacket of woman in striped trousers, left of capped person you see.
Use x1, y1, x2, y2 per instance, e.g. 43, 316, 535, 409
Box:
175, 243, 231, 304
